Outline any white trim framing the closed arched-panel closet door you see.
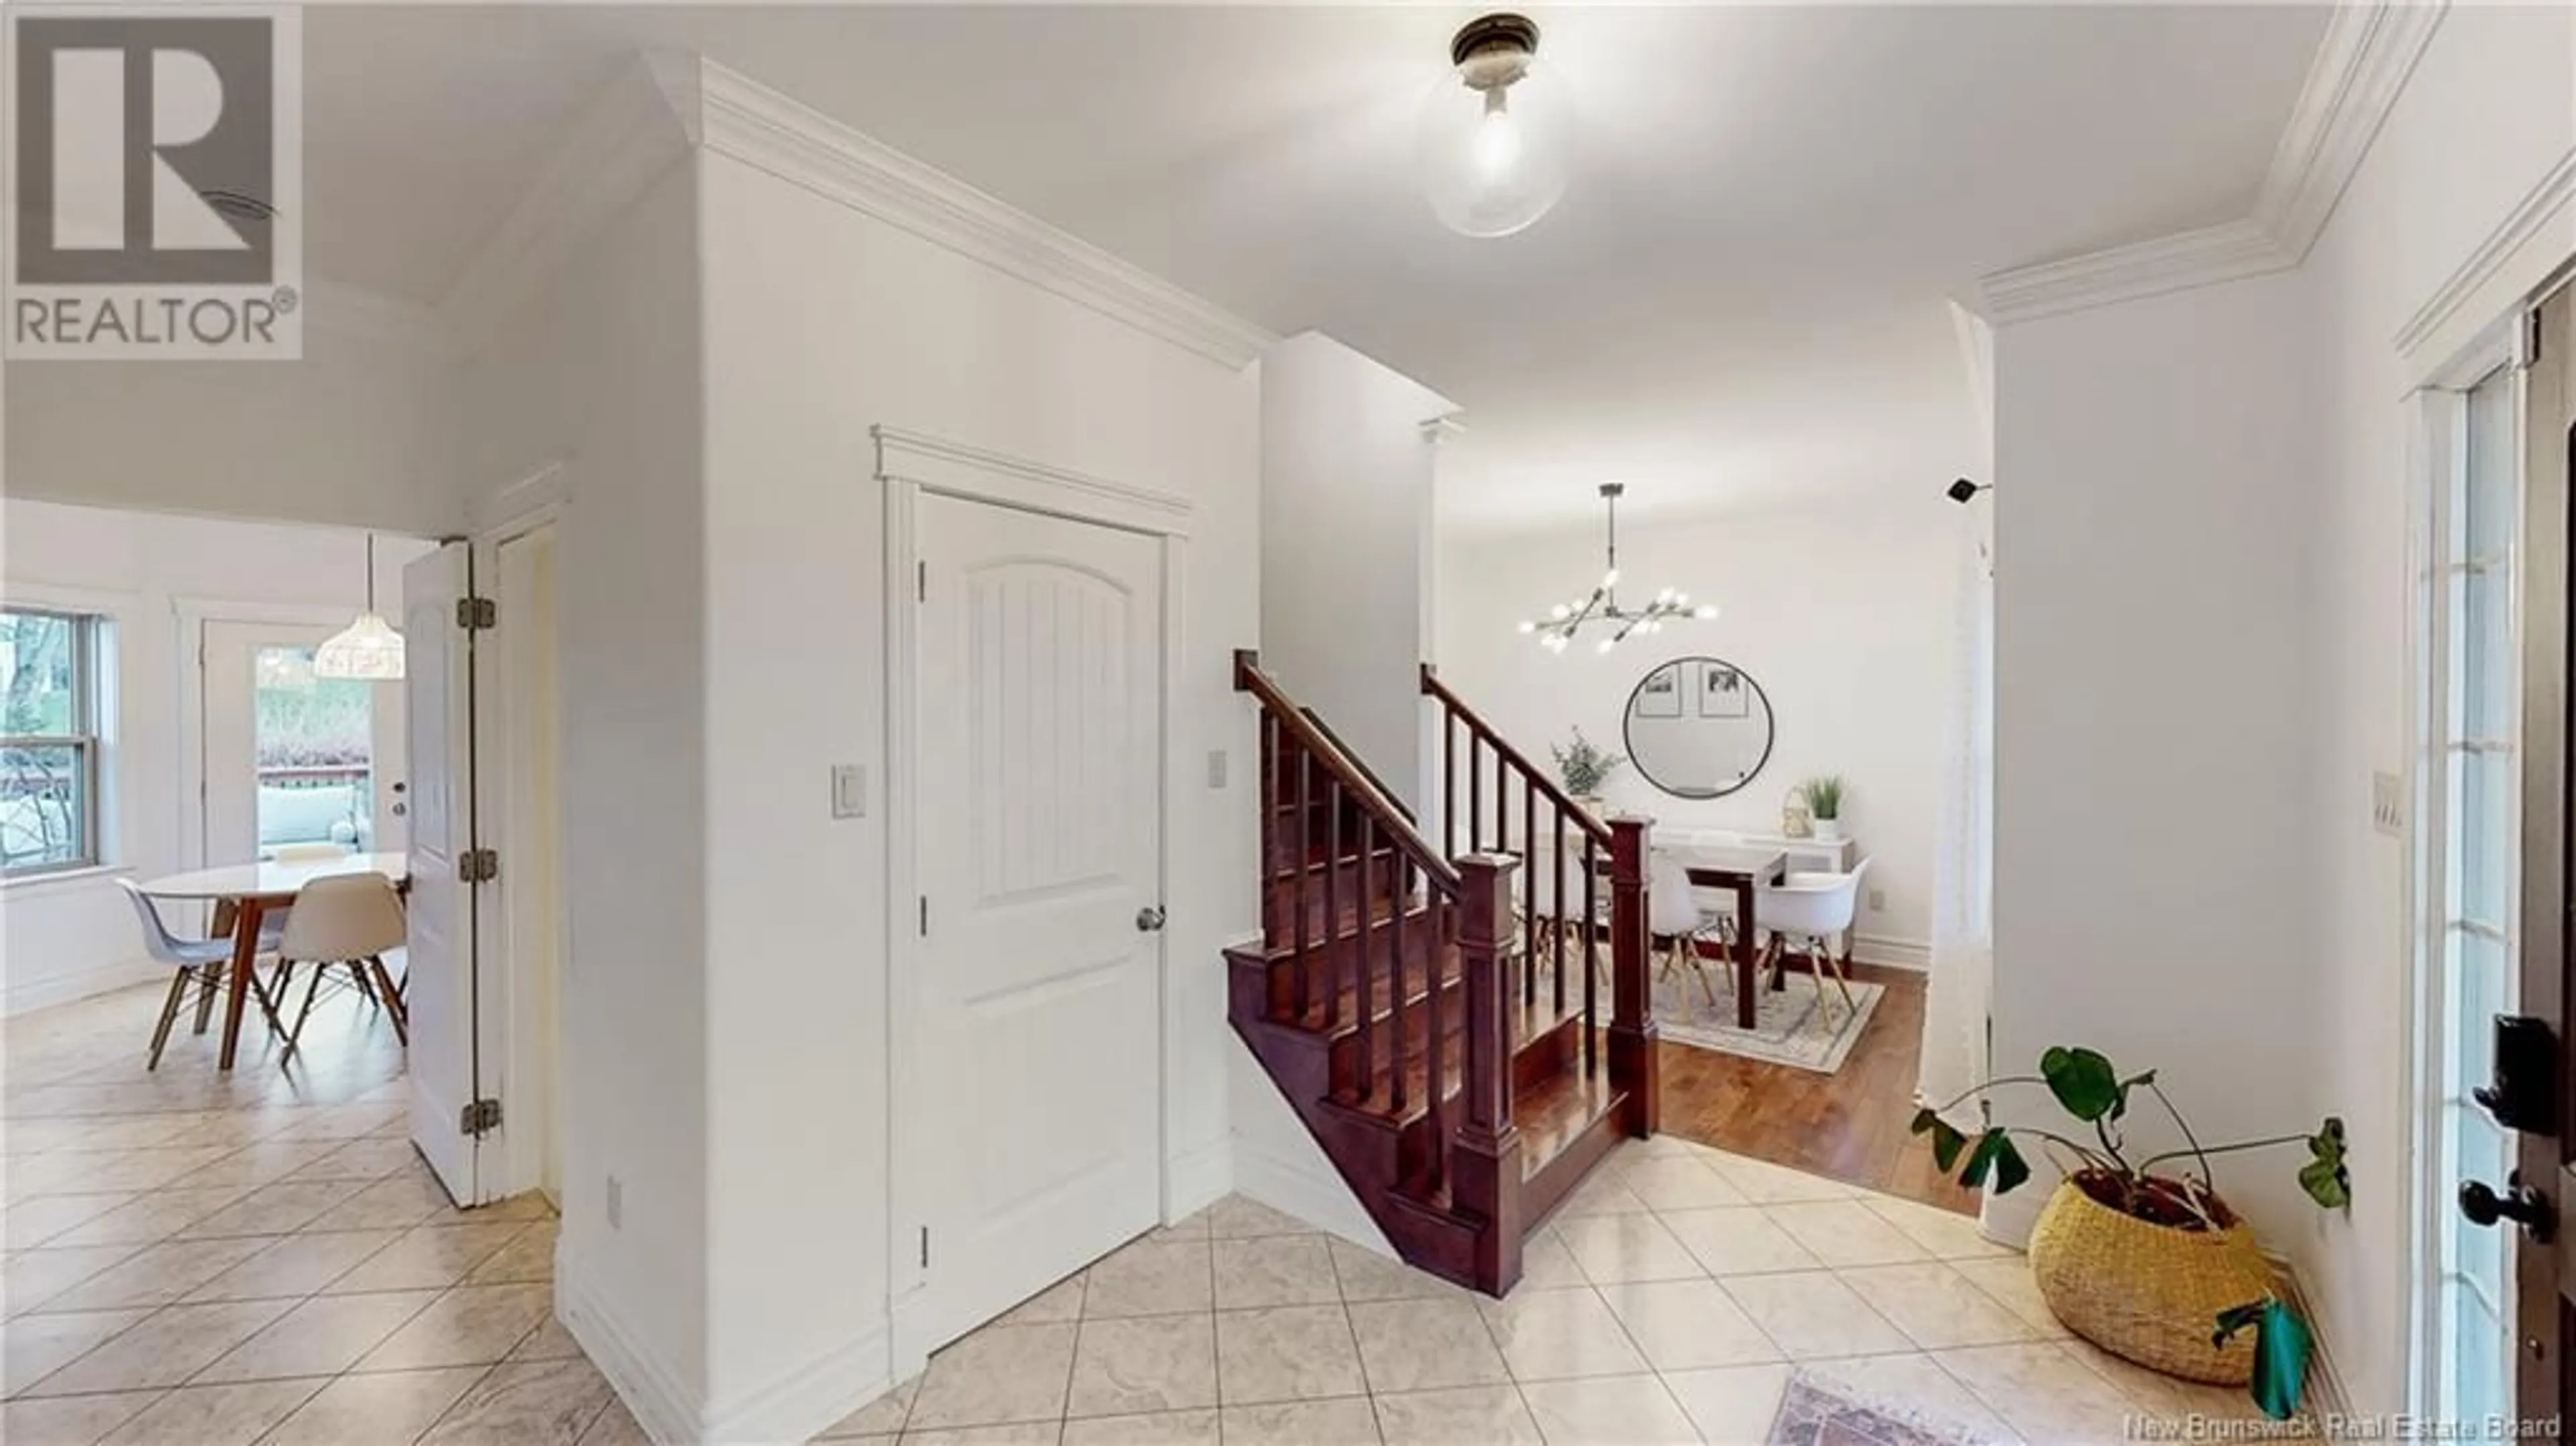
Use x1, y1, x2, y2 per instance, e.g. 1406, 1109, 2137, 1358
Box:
868, 425, 1190, 1382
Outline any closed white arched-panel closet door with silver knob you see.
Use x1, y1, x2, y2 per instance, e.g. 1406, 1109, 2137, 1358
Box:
917, 498, 1162, 1343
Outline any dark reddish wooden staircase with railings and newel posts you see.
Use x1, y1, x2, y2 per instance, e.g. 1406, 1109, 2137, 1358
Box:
1226, 652, 1654, 1296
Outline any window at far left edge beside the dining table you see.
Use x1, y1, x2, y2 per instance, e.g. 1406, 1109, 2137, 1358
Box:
0, 608, 98, 879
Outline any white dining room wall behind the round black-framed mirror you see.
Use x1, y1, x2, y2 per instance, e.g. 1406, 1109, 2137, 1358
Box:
1440, 502, 1966, 964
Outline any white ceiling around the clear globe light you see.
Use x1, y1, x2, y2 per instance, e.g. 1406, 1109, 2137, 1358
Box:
307, 5, 2326, 529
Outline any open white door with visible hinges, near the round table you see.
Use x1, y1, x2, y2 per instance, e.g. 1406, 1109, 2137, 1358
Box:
402, 544, 482, 1204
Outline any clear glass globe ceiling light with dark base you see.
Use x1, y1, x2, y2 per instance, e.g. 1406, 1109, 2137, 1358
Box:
1414, 15, 1566, 237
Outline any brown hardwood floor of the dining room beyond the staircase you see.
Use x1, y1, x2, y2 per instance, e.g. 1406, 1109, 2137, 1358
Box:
1662, 964, 1976, 1214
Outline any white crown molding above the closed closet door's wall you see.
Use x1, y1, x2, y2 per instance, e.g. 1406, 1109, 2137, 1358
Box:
690, 59, 1278, 366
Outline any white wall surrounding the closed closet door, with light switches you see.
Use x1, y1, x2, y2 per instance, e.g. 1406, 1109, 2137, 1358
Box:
700, 155, 1260, 1428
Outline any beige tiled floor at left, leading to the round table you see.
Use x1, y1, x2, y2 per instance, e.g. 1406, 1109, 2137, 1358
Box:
0, 987, 644, 1446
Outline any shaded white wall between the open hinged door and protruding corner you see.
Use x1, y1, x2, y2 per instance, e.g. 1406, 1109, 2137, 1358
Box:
451, 162, 706, 1400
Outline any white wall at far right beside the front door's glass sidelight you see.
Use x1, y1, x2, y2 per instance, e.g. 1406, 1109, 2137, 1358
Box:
2298, 5, 2576, 1410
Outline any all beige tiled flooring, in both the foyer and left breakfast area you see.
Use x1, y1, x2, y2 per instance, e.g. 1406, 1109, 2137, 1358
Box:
15, 974, 2249, 1446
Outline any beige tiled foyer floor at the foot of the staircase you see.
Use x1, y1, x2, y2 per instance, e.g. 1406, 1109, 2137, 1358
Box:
827, 1137, 2287, 1446
